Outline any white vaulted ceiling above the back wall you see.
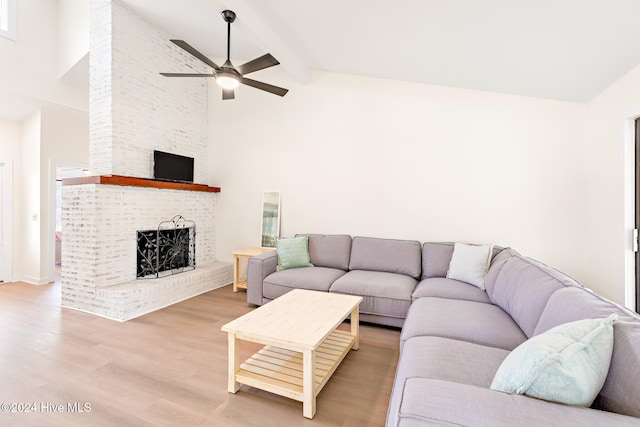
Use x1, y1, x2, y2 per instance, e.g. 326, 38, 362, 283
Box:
117, 0, 640, 102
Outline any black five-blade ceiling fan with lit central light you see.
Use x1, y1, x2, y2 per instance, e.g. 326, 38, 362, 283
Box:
160, 10, 289, 99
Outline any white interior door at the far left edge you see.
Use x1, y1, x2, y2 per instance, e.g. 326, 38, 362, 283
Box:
0, 161, 13, 282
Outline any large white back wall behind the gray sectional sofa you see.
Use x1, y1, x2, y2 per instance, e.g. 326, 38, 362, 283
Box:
209, 68, 588, 288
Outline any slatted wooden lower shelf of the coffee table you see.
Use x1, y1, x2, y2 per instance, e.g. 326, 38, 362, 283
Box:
235, 330, 356, 402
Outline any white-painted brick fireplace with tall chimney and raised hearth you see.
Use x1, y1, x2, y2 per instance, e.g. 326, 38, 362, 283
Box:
62, 0, 233, 321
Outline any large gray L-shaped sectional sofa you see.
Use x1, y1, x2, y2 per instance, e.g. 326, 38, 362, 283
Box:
247, 235, 640, 427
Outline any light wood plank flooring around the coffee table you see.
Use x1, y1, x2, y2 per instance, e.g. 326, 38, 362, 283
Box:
0, 282, 400, 427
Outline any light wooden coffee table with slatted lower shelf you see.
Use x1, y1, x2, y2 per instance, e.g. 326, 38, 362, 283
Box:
222, 289, 362, 418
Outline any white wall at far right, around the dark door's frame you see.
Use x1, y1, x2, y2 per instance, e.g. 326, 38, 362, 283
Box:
584, 61, 640, 306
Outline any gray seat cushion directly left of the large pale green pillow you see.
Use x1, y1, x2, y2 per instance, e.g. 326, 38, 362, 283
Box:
388, 337, 509, 425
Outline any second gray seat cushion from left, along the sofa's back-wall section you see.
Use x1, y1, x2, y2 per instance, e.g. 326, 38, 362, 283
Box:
329, 270, 418, 319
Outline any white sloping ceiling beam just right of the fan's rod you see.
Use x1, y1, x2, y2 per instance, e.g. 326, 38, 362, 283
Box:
219, 0, 311, 84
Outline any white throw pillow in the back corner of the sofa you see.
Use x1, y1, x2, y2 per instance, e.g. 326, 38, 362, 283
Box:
447, 243, 493, 290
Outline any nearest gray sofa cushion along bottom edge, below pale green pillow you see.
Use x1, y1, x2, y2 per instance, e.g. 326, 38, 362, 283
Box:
387, 378, 638, 427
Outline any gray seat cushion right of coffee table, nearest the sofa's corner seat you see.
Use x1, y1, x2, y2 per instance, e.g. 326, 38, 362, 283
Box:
400, 297, 527, 350
